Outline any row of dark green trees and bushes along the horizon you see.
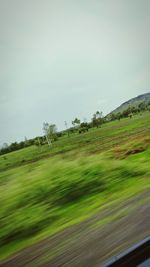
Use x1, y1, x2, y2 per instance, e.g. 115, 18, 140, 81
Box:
0, 102, 150, 155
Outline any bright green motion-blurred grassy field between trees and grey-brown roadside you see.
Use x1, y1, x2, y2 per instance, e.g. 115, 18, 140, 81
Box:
0, 112, 150, 258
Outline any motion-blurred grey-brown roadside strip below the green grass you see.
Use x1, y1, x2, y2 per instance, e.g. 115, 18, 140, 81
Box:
0, 191, 150, 267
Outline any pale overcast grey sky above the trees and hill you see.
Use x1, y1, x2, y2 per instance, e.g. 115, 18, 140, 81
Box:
0, 0, 150, 145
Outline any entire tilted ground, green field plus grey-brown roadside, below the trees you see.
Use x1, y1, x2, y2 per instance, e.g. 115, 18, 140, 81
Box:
0, 111, 150, 267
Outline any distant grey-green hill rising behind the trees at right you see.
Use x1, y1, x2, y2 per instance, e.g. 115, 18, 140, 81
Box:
108, 93, 150, 115
